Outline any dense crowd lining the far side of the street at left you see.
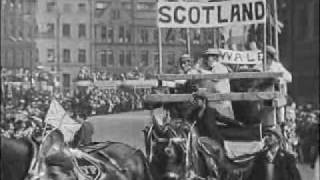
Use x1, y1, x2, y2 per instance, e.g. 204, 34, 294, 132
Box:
0, 82, 150, 138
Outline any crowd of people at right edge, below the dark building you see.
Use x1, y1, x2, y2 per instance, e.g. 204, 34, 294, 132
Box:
282, 102, 320, 165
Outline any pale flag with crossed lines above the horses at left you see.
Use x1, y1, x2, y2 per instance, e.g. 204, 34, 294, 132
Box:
45, 99, 81, 142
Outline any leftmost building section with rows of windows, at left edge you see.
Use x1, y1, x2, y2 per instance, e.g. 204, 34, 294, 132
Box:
1, 0, 37, 69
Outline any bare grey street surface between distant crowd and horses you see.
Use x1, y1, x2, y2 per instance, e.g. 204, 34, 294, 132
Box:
89, 110, 314, 180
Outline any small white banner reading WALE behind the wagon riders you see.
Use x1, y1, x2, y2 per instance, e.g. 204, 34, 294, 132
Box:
219, 49, 263, 64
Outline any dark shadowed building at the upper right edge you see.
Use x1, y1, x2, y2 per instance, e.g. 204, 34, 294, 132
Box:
279, 0, 319, 105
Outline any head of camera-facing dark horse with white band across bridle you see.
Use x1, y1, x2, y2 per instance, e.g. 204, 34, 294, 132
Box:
150, 114, 194, 180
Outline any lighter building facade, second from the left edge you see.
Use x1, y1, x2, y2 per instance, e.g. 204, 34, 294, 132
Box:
36, 0, 92, 91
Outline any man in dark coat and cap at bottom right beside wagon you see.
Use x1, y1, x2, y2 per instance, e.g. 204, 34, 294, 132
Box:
248, 128, 301, 180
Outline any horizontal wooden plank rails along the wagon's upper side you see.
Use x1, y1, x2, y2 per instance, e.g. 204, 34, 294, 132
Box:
146, 72, 286, 107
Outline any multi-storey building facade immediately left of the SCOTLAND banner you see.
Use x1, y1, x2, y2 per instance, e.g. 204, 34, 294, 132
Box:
94, 0, 185, 73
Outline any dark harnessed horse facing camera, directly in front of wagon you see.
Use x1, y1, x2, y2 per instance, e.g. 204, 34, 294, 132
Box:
145, 105, 260, 180
